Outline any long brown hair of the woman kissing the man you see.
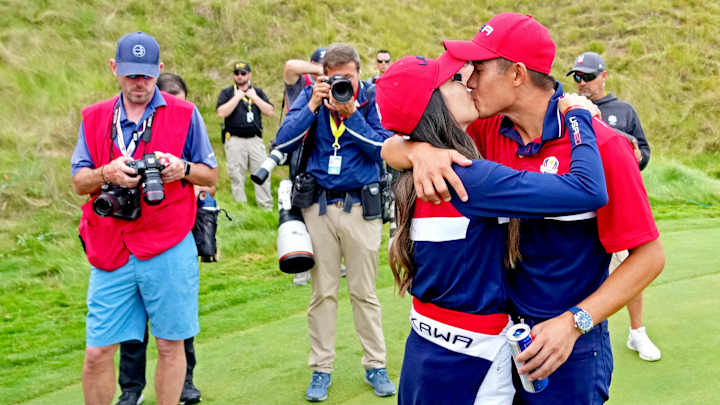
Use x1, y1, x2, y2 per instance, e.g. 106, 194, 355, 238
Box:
389, 89, 520, 296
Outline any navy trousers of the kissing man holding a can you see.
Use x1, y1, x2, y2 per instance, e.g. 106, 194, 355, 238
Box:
513, 318, 613, 405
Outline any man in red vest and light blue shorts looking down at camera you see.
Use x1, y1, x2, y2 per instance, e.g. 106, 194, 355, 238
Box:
72, 32, 217, 405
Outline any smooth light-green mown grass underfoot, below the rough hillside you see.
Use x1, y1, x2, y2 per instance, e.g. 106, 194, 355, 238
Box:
14, 219, 720, 405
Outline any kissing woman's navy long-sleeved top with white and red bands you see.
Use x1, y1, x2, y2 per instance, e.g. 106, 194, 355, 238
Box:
410, 110, 607, 314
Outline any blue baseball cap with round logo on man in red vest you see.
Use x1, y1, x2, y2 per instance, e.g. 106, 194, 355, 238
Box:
115, 31, 160, 77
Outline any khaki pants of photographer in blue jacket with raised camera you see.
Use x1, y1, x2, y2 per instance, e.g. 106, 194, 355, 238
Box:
303, 203, 385, 373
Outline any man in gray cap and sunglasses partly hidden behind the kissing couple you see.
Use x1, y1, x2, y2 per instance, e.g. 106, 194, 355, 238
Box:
567, 52, 661, 361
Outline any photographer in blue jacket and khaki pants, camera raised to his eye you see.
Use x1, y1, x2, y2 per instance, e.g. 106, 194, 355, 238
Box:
276, 44, 395, 401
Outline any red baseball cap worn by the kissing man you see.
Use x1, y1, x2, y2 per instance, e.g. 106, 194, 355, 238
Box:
443, 13, 555, 74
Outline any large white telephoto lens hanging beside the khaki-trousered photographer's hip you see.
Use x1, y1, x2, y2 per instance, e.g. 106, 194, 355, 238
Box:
277, 179, 315, 274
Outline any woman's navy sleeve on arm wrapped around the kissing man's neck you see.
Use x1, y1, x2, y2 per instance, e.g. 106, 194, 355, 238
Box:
451, 110, 608, 218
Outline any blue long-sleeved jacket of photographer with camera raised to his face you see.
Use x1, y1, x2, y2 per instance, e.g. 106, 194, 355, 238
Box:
276, 82, 392, 191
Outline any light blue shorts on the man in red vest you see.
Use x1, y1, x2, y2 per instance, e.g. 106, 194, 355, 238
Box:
85, 233, 200, 346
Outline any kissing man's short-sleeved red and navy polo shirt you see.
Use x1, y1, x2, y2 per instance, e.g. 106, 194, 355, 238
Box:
468, 83, 659, 320
